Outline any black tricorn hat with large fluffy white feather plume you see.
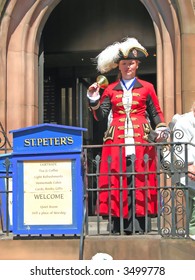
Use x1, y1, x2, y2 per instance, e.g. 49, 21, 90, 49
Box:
96, 37, 148, 73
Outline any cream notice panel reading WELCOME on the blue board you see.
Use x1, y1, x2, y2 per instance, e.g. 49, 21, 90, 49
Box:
23, 160, 73, 225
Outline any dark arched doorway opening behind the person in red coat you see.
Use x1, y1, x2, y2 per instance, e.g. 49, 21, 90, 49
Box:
39, 0, 156, 144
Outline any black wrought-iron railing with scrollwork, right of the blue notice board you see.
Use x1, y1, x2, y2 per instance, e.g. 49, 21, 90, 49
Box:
83, 128, 194, 238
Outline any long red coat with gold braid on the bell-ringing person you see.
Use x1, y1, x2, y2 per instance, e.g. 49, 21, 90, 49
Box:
90, 78, 166, 218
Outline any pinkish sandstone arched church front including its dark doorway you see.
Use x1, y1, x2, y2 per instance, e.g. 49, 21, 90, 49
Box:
0, 0, 195, 142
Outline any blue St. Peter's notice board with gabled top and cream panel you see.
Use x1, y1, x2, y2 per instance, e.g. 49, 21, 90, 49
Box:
11, 124, 86, 234
